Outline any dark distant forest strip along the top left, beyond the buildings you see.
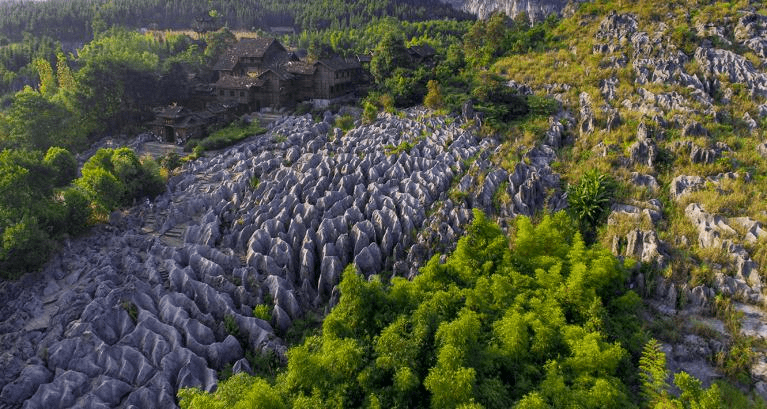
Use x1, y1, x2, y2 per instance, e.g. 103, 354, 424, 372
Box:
0, 0, 470, 42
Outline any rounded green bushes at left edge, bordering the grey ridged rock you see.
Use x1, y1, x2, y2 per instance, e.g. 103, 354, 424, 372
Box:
0, 147, 165, 279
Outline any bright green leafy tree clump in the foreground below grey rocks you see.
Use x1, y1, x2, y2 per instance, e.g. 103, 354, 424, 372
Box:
179, 212, 656, 408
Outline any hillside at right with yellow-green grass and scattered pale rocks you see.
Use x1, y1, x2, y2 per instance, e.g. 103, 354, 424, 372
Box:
491, 2, 767, 396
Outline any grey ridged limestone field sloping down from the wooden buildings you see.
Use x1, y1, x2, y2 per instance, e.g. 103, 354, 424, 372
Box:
0, 110, 572, 408
